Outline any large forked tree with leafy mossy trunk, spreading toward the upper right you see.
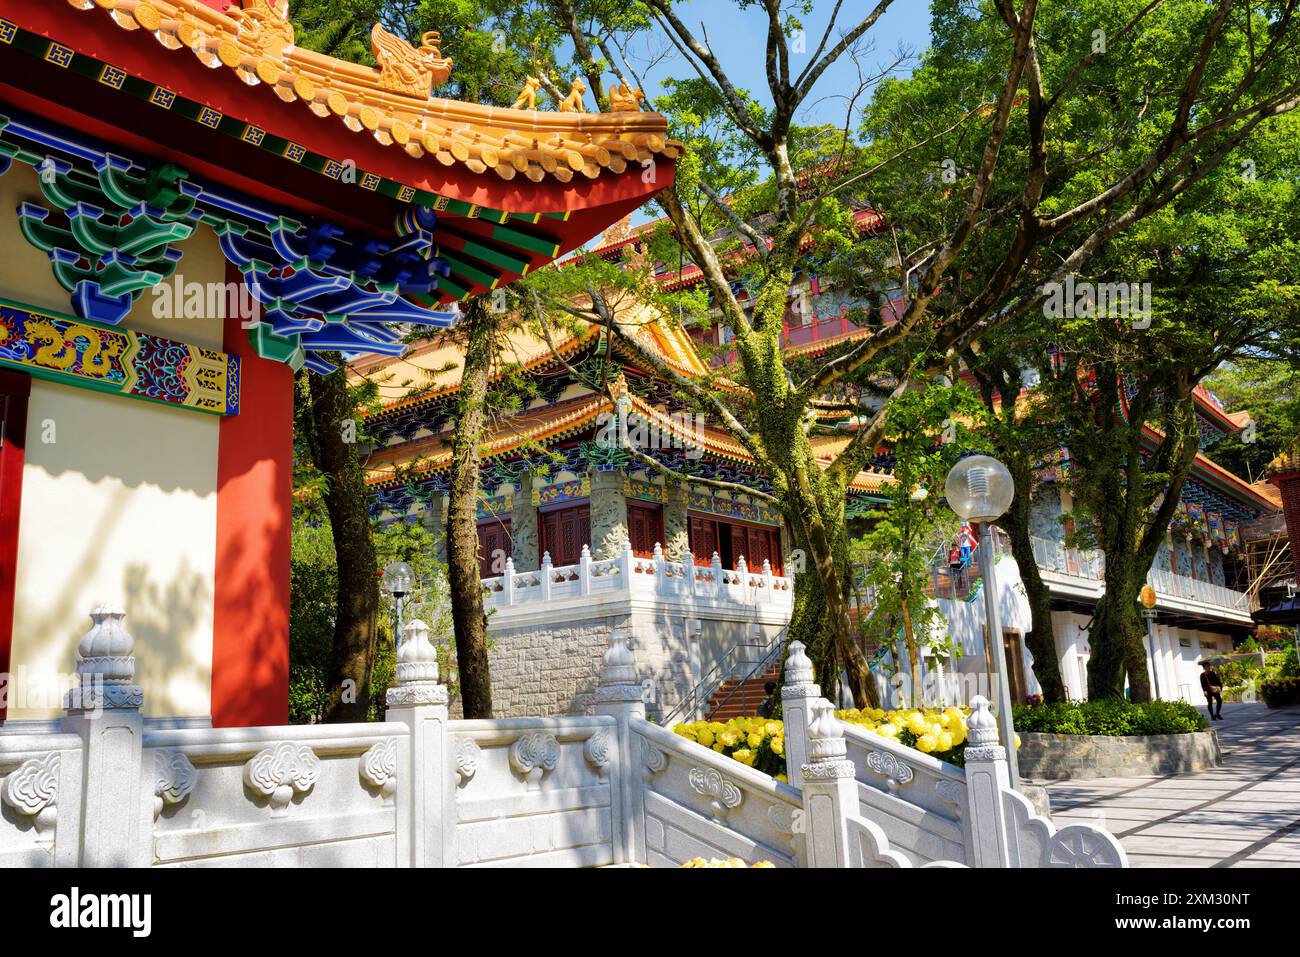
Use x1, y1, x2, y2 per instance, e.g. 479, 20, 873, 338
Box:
533, 0, 1300, 703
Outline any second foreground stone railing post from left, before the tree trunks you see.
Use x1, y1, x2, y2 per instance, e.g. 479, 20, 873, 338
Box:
385, 619, 456, 867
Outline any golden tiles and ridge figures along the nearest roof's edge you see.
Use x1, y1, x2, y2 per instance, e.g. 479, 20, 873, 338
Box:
67, 0, 683, 182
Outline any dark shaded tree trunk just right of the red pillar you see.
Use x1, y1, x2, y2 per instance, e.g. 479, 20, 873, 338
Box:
307, 355, 380, 722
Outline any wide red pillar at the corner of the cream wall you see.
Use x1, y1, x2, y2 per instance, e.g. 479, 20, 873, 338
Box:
212, 269, 294, 728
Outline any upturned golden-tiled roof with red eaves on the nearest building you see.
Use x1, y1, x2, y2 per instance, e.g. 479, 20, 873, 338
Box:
0, 0, 680, 302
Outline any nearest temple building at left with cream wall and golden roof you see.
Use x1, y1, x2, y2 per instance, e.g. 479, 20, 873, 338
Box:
0, 0, 680, 729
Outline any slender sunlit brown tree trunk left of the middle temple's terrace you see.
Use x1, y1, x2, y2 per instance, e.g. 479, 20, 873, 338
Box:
447, 298, 494, 718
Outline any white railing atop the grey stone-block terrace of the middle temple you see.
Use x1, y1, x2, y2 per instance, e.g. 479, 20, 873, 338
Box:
482, 544, 794, 611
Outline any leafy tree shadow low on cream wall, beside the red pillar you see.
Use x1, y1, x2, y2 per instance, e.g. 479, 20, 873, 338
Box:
122, 559, 212, 716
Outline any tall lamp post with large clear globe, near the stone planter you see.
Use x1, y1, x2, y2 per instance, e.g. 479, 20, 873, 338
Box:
944, 455, 1021, 791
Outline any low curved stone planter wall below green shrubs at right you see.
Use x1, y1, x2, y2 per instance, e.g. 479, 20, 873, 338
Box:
1017, 731, 1223, 781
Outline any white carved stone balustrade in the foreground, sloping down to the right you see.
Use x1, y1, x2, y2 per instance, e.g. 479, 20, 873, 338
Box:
0, 605, 1126, 867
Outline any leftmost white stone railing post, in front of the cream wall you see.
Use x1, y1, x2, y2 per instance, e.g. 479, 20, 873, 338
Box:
62, 603, 144, 867
